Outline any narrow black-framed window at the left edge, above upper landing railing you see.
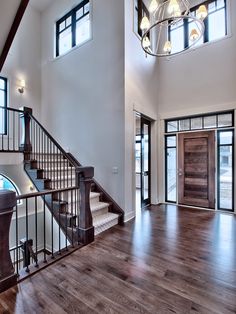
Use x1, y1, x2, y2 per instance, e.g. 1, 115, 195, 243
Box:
0, 76, 7, 134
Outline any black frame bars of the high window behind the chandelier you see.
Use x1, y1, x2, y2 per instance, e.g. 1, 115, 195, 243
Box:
168, 0, 228, 49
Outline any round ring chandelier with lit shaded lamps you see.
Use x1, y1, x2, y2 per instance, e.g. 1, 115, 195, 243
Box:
140, 0, 207, 57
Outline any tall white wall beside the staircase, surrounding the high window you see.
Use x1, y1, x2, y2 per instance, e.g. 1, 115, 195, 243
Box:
42, 0, 124, 207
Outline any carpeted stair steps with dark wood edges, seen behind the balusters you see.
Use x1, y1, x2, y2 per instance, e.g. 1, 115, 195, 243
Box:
25, 153, 120, 235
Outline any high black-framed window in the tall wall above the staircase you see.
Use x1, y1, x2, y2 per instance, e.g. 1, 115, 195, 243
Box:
56, 0, 91, 56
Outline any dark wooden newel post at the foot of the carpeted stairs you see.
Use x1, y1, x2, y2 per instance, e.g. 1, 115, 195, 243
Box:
76, 167, 94, 245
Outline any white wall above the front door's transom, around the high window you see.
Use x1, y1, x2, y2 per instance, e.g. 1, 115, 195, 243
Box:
157, 0, 236, 117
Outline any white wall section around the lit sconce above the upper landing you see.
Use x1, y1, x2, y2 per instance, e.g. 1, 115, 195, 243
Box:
0, 3, 41, 117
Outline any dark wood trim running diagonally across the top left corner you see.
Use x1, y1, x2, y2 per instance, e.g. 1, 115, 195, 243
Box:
0, 0, 29, 72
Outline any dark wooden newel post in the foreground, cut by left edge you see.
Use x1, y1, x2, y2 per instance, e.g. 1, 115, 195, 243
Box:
0, 190, 17, 292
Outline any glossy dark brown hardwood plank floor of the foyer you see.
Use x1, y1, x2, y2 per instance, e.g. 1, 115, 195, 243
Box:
0, 205, 236, 314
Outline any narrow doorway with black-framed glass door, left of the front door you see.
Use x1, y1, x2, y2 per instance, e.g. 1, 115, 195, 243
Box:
135, 113, 151, 209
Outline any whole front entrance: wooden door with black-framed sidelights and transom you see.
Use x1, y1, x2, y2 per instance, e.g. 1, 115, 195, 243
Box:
165, 111, 234, 211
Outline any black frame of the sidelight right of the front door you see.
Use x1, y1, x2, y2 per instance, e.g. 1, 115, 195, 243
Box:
217, 128, 235, 212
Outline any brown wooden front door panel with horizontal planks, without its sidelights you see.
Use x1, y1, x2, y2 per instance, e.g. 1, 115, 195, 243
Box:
178, 131, 215, 208
